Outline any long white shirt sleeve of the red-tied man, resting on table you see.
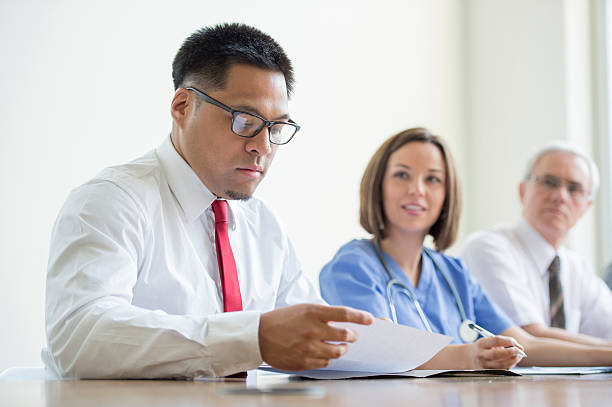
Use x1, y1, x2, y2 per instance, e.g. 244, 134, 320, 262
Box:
45, 181, 261, 378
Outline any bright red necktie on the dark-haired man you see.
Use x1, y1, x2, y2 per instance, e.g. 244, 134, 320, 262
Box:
212, 200, 242, 312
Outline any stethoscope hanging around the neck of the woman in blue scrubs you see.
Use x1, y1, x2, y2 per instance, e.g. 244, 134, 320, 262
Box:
374, 239, 478, 343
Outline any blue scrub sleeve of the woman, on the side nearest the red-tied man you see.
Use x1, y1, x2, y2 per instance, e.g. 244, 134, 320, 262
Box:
319, 245, 391, 318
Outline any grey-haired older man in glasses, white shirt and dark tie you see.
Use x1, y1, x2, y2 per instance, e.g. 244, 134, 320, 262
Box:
462, 144, 612, 346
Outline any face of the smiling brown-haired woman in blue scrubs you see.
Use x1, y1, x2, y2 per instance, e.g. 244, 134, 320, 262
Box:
382, 141, 446, 238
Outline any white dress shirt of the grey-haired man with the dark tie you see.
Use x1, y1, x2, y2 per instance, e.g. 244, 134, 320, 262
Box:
461, 218, 612, 339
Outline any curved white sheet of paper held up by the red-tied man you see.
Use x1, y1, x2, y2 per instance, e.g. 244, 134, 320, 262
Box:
326, 319, 452, 373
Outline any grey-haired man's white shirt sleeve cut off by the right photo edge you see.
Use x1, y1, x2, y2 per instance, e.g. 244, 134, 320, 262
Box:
580, 262, 612, 340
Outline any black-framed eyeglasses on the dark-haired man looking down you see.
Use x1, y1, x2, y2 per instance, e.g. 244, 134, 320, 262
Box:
185, 87, 300, 145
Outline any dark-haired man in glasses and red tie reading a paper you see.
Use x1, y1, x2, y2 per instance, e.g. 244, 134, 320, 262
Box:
43, 24, 372, 378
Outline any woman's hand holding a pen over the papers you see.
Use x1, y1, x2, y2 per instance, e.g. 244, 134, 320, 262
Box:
467, 335, 524, 369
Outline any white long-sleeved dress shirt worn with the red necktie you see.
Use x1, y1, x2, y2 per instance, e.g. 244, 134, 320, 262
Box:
43, 137, 323, 378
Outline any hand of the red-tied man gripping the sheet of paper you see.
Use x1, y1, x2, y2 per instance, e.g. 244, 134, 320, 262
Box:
259, 304, 374, 371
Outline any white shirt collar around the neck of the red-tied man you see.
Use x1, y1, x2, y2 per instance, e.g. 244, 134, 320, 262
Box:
156, 136, 224, 223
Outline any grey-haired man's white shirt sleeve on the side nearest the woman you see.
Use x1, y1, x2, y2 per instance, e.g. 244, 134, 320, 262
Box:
461, 232, 546, 326
